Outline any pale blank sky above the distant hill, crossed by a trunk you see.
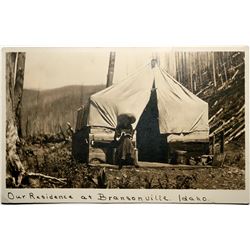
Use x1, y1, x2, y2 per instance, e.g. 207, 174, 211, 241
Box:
24, 48, 161, 89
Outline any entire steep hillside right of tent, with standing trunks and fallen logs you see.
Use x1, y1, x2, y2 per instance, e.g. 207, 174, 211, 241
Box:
166, 51, 245, 147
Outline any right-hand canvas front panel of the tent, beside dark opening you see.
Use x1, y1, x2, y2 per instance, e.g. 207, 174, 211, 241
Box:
154, 68, 208, 133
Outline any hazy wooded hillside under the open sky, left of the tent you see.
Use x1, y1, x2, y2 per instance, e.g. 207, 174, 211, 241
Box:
22, 85, 104, 136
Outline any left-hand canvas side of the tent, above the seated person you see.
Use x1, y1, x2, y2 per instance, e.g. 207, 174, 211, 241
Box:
88, 64, 153, 128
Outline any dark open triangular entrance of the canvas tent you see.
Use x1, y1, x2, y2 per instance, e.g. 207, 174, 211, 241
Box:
136, 83, 168, 162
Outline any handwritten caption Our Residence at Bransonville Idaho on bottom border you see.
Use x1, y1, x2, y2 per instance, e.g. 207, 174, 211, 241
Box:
7, 192, 208, 203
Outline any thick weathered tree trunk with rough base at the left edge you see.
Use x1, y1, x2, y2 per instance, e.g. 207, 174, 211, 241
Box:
6, 52, 25, 186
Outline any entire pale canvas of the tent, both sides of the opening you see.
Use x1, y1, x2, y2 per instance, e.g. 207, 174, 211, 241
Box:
85, 61, 209, 141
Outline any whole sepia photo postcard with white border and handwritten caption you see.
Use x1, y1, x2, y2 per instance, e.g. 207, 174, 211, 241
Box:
1, 46, 249, 204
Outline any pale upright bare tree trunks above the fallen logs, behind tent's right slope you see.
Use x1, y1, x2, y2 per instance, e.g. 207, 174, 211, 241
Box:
164, 51, 245, 94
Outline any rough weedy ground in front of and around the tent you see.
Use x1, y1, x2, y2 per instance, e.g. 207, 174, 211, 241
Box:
11, 137, 245, 190
